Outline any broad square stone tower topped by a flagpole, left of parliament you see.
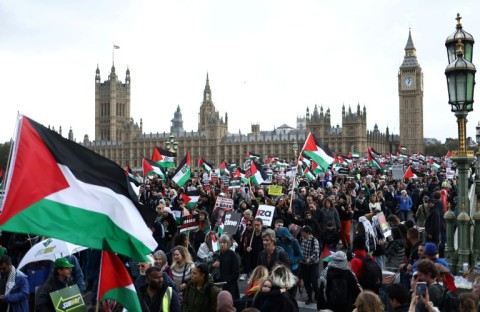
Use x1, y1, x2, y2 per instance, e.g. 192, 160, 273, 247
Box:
95, 65, 130, 141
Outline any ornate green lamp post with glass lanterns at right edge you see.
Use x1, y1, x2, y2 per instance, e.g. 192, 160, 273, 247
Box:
445, 15, 476, 273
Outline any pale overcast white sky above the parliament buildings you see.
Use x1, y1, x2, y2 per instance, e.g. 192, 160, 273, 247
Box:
0, 0, 480, 142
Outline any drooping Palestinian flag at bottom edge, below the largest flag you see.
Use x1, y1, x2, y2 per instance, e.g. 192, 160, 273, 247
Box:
97, 251, 142, 311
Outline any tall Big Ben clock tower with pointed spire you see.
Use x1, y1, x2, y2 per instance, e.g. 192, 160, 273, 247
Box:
398, 31, 424, 154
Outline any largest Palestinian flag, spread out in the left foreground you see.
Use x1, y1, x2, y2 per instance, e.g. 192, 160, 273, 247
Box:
0, 116, 157, 261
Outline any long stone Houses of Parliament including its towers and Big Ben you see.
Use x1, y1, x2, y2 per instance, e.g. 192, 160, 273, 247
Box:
81, 33, 424, 168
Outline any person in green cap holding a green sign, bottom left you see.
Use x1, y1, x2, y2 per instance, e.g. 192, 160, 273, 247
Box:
35, 258, 73, 312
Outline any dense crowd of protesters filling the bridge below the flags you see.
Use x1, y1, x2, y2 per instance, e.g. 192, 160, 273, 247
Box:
0, 158, 480, 312
